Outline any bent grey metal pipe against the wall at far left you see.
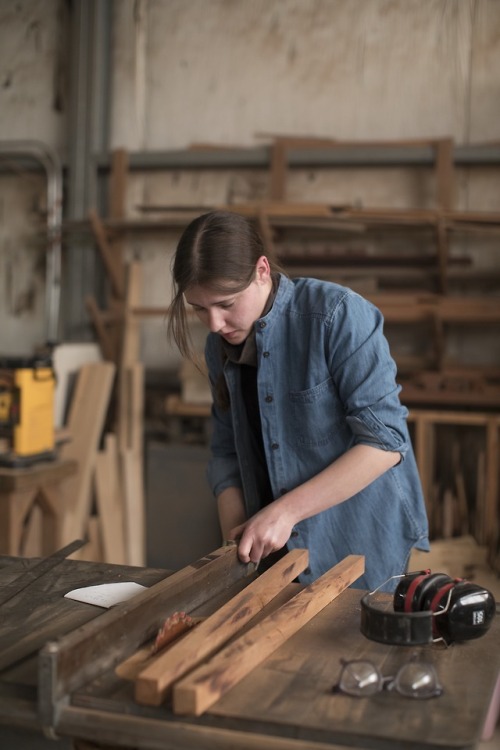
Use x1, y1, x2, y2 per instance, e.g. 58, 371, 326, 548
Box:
0, 140, 63, 342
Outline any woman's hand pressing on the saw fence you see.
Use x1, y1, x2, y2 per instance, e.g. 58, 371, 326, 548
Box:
230, 500, 293, 564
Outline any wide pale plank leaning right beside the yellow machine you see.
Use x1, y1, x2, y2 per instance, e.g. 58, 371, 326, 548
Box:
61, 362, 115, 544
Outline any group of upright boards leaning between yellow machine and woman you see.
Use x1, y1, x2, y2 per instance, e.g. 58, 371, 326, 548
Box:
58, 263, 145, 566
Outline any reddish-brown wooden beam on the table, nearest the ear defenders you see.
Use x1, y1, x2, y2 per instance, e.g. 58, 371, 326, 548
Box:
173, 555, 364, 716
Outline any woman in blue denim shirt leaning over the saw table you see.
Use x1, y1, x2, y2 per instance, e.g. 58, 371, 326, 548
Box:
168, 211, 428, 589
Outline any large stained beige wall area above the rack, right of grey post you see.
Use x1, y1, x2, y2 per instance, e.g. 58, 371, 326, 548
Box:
112, 0, 500, 149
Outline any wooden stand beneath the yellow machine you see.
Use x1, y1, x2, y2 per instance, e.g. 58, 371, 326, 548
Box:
0, 460, 78, 557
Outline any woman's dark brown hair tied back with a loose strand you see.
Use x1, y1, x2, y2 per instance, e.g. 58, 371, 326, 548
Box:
167, 211, 282, 360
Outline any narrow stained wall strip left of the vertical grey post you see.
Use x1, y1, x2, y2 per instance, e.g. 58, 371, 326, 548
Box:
0, 0, 67, 355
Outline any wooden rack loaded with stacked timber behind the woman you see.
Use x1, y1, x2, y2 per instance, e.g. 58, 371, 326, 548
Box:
76, 136, 500, 572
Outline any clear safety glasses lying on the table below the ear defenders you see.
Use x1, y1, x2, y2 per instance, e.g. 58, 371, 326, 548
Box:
333, 660, 443, 698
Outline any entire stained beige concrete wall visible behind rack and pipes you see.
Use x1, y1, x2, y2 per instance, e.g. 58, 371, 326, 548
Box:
0, 0, 500, 368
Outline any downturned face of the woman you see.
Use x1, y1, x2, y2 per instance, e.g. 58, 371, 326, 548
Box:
185, 255, 272, 344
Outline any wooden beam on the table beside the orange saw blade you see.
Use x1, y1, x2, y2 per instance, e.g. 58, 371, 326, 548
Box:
135, 549, 309, 706
